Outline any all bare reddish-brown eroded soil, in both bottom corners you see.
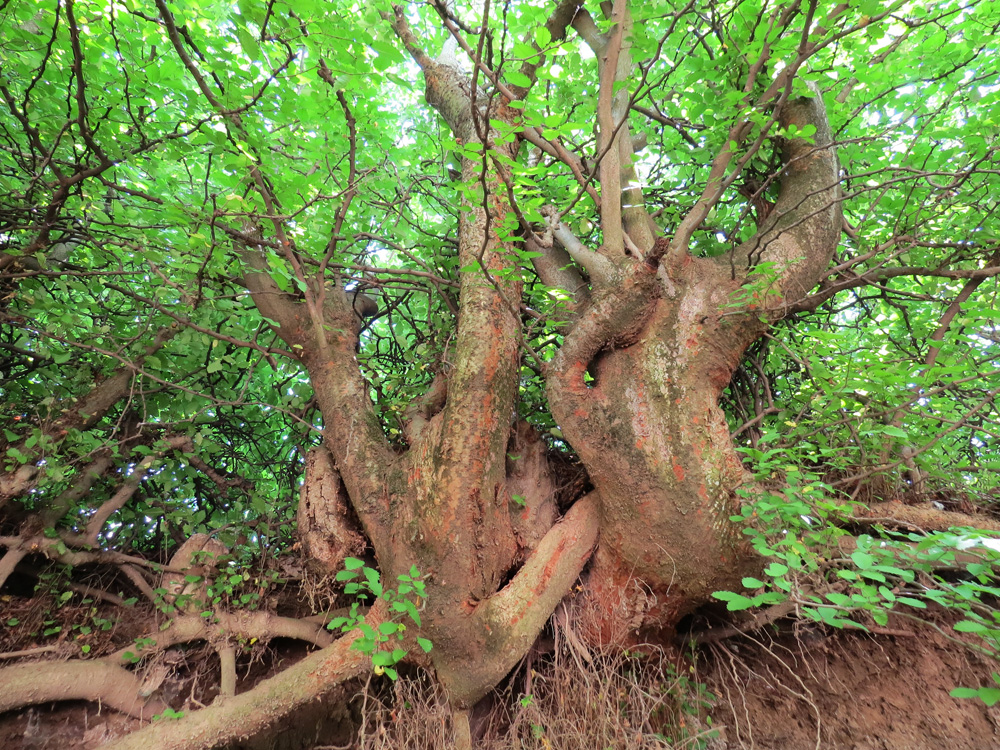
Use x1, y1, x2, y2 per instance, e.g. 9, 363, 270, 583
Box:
0, 623, 1000, 750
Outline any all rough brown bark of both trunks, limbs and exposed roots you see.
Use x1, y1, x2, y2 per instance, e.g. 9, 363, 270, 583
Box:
0, 0, 868, 748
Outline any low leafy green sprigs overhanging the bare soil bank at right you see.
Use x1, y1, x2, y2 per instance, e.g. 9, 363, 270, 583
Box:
713, 465, 1000, 702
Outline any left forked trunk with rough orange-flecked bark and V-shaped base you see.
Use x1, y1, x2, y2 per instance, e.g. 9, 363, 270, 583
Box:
234, 4, 597, 706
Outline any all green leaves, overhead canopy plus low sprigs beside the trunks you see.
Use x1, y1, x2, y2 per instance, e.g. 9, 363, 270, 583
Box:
0, 0, 1000, 716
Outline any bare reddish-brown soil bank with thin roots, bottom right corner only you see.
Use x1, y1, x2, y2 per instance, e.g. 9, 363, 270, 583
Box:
702, 624, 1000, 750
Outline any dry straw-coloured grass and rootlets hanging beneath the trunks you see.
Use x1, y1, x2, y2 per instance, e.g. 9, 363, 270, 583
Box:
356, 651, 713, 750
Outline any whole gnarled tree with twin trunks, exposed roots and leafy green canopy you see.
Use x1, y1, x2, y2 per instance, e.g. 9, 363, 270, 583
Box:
0, 0, 1000, 747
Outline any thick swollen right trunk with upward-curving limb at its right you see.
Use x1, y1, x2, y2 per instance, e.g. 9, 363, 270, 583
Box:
549, 91, 841, 641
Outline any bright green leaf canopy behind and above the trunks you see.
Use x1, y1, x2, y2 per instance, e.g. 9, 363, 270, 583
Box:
0, 0, 1000, 553
